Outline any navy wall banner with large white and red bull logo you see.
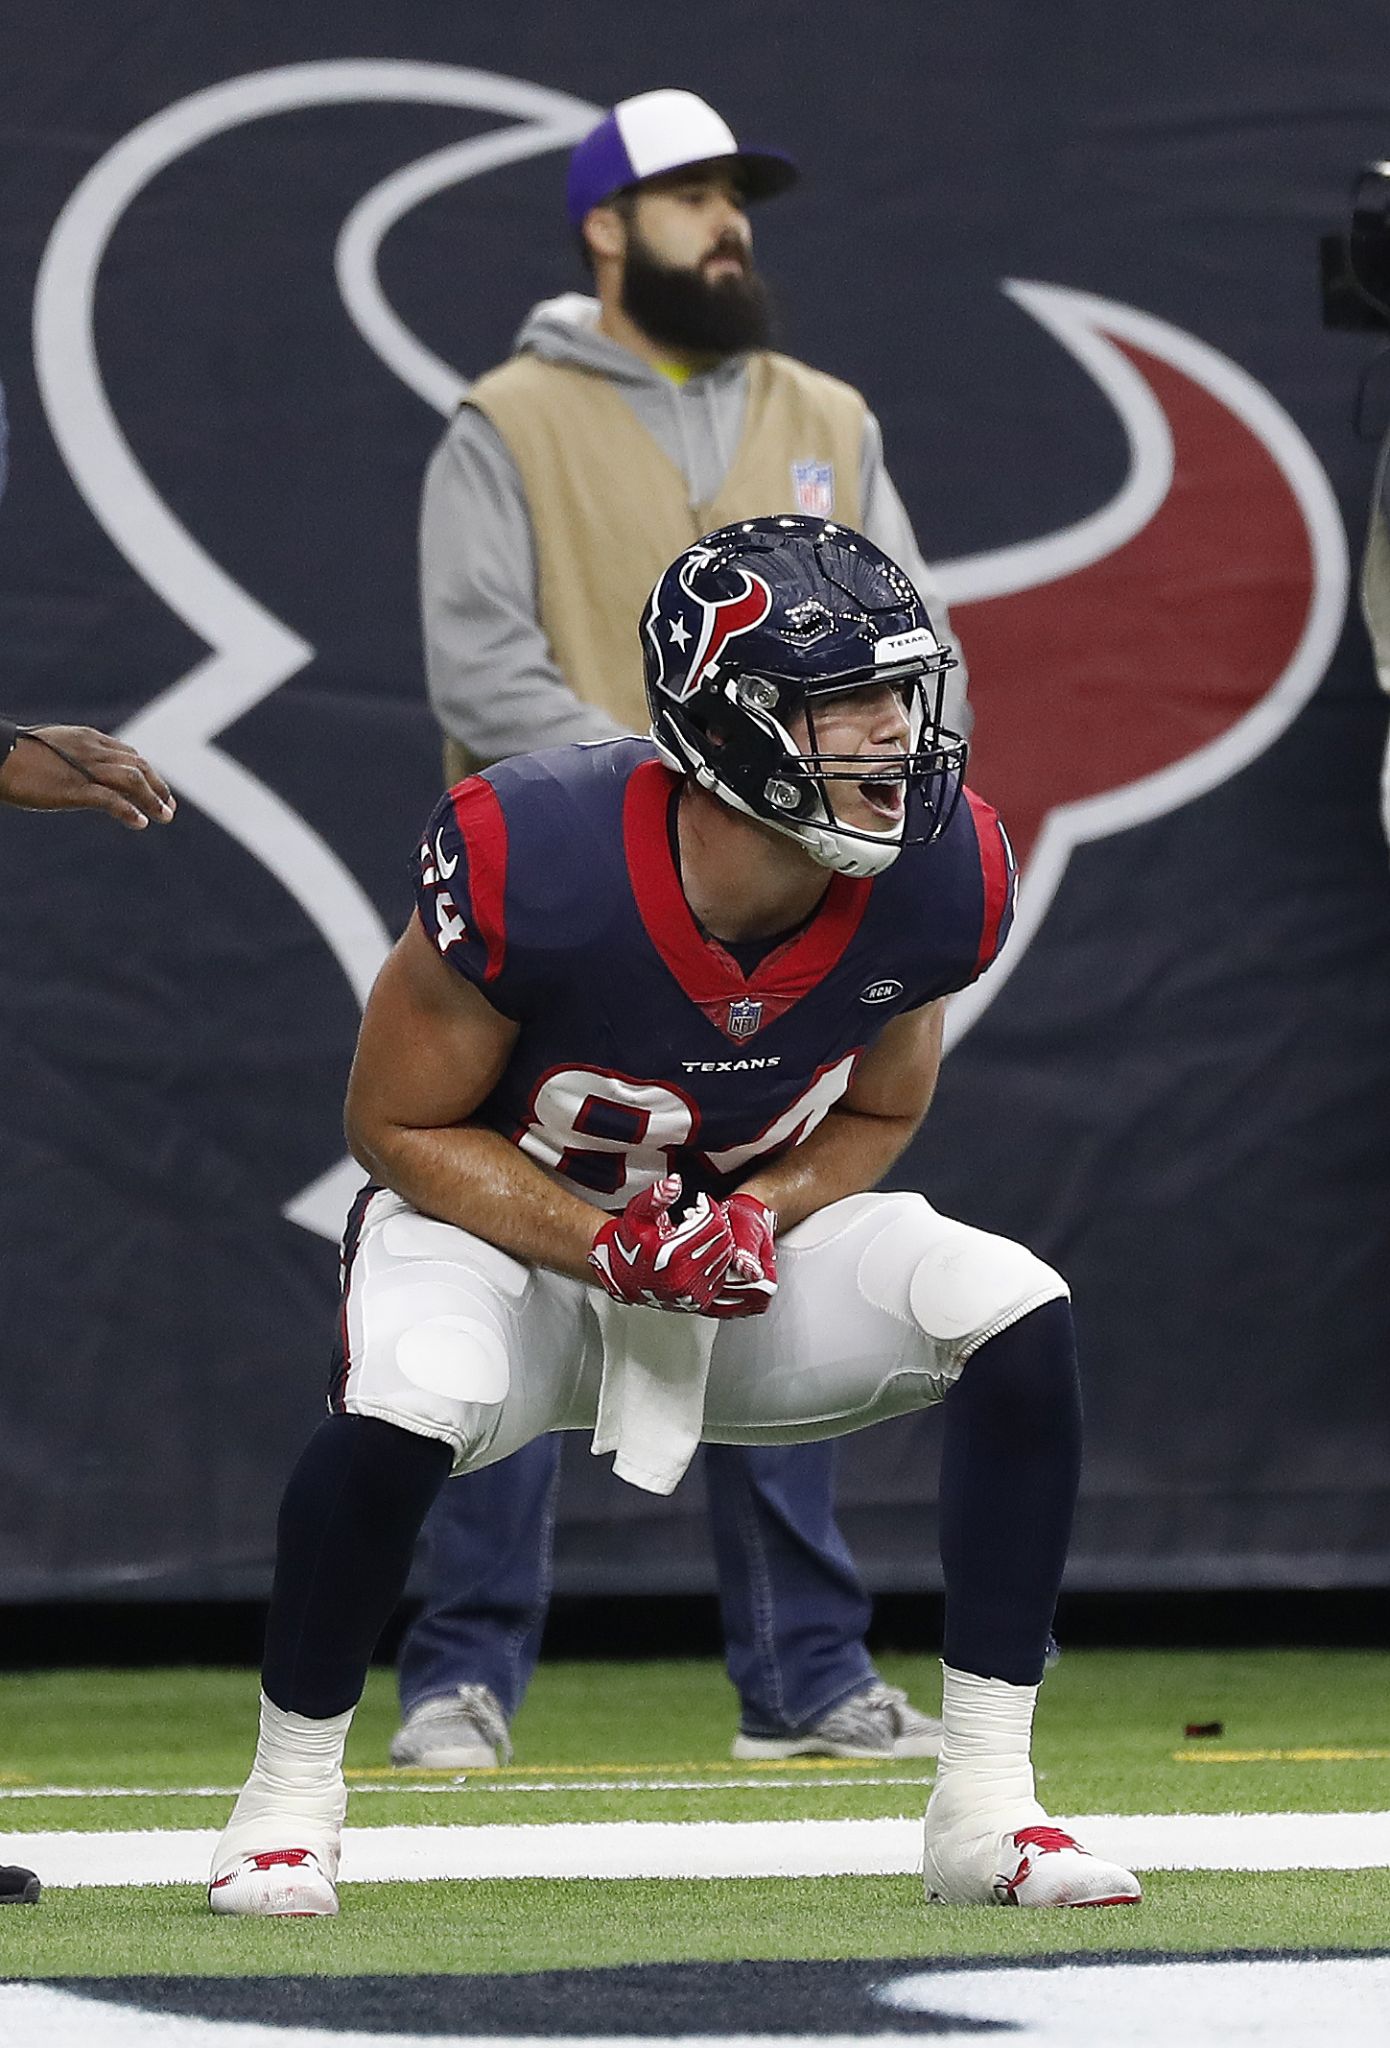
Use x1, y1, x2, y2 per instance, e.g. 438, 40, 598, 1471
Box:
0, 0, 1390, 1599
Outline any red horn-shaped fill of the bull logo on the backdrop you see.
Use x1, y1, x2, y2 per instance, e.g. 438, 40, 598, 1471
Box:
952, 315, 1314, 860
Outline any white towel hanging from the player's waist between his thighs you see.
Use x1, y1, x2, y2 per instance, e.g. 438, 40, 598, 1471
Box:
592, 1294, 719, 1493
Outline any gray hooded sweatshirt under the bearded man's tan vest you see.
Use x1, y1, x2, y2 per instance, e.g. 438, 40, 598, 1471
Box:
420, 293, 968, 762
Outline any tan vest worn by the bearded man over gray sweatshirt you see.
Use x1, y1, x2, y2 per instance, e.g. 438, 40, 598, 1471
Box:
456, 354, 864, 774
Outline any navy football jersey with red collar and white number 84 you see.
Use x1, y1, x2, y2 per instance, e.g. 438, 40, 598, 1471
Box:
418, 739, 1013, 1210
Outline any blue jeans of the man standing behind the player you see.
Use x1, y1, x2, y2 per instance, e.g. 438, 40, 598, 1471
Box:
399, 1436, 876, 1735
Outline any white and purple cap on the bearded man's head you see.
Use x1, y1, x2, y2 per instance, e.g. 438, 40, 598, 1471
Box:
569, 86, 798, 227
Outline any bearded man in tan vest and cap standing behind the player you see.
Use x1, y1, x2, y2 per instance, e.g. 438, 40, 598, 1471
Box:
391, 90, 968, 1769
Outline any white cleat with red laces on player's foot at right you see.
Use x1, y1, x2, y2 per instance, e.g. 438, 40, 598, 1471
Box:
921, 1812, 1144, 1907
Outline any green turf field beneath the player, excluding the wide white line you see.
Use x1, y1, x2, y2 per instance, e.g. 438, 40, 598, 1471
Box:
0, 1651, 1390, 1976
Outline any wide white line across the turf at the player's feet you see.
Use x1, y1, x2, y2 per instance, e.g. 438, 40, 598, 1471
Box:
6, 1812, 1390, 1886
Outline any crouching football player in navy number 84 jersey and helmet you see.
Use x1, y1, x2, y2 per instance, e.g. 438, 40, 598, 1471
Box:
209, 516, 1140, 1915
